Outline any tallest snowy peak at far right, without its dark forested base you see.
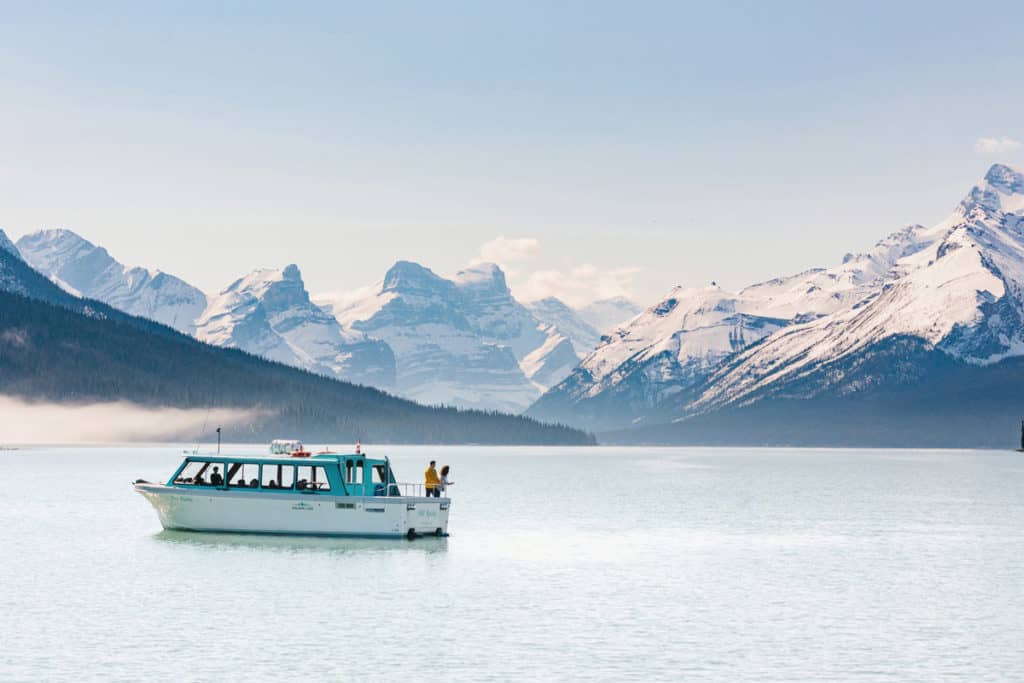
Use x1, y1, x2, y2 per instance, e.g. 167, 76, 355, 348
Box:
693, 165, 1024, 410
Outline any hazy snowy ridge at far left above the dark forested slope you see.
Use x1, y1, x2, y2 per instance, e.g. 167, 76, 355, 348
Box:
17, 229, 206, 333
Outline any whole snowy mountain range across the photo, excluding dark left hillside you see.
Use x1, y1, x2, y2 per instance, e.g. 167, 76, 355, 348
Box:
12, 164, 1024, 445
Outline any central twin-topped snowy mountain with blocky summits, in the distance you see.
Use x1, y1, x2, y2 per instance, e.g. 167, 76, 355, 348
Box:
316, 261, 593, 412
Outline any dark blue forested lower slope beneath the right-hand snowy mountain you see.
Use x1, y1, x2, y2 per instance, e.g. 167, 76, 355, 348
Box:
599, 337, 1024, 449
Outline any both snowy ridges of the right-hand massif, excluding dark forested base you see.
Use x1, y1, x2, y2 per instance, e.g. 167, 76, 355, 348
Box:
529, 165, 1024, 436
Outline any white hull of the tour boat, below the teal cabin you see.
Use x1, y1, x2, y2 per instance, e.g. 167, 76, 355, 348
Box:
135, 483, 451, 538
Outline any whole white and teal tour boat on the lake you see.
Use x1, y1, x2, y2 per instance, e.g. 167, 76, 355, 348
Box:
133, 441, 451, 539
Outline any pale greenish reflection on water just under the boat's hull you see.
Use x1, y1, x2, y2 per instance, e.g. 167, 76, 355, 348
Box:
153, 529, 449, 555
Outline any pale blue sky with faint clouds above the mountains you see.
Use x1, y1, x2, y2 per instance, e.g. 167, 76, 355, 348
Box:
0, 1, 1024, 304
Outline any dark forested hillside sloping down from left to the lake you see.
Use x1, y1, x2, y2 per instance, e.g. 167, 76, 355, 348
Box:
0, 286, 594, 444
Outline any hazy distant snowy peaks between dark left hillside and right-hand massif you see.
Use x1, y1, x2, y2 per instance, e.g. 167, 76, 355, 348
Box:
16, 229, 640, 413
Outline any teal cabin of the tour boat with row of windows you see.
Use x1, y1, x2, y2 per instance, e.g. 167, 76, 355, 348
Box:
167, 454, 400, 496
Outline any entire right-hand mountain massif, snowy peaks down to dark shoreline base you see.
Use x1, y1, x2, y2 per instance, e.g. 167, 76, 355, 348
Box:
527, 165, 1024, 445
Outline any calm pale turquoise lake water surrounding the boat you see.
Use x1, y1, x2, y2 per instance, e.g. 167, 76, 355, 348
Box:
0, 446, 1024, 681
